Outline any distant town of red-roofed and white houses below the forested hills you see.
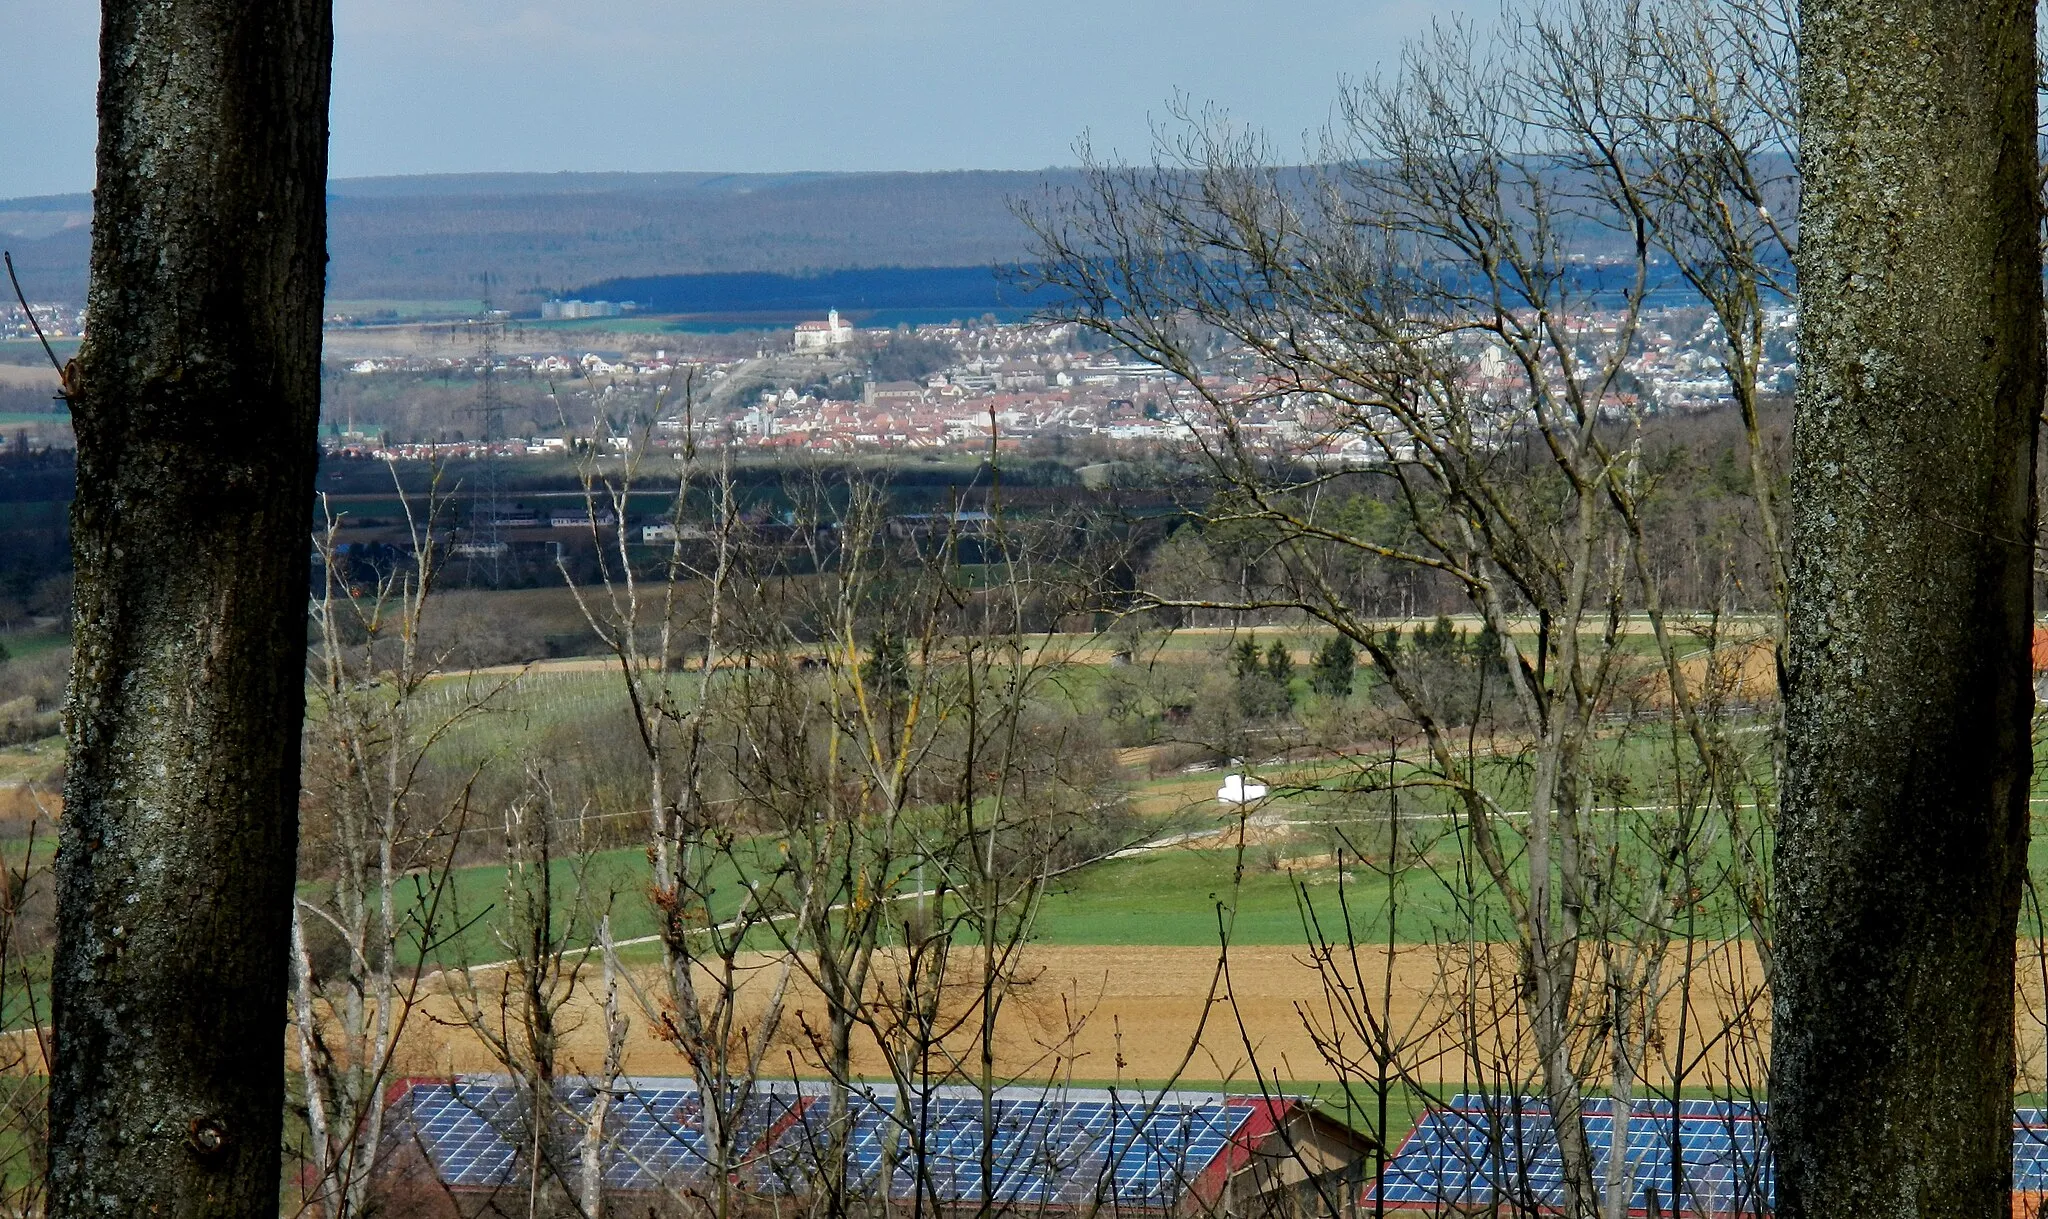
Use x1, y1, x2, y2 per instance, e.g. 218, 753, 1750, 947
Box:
315, 299, 1796, 463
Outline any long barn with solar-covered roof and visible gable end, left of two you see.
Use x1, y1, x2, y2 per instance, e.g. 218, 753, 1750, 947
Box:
387, 1076, 1372, 1215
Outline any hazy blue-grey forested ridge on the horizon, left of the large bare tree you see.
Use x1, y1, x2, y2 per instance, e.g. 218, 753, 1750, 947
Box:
0, 170, 1077, 307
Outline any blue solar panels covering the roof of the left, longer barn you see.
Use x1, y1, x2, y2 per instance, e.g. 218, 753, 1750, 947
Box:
391, 1076, 1253, 1209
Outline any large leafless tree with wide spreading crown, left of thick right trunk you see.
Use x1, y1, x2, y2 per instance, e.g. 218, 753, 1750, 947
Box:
1030, 6, 1794, 1215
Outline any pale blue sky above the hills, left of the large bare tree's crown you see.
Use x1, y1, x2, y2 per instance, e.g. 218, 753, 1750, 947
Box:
0, 0, 1444, 199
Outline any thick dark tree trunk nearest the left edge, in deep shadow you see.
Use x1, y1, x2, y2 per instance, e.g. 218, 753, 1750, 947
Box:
51, 0, 332, 1217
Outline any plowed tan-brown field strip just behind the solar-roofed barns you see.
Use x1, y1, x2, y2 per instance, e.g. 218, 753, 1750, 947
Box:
372, 947, 1763, 1082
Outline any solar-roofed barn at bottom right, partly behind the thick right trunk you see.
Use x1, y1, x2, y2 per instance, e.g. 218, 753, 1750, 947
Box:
1364, 1094, 2048, 1219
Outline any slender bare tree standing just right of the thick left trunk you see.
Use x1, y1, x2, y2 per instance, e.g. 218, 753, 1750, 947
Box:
291, 479, 510, 1219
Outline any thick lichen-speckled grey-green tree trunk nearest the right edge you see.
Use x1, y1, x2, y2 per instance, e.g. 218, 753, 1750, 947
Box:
1772, 0, 2042, 1219
